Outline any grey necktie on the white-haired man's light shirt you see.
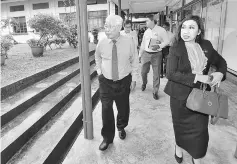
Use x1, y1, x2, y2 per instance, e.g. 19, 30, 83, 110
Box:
112, 40, 119, 81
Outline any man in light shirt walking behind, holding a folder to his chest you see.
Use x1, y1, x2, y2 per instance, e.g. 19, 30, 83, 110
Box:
139, 15, 169, 100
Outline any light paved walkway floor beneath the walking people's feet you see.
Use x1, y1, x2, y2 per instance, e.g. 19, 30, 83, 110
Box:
63, 68, 237, 164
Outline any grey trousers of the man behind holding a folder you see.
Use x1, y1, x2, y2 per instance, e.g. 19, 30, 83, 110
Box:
141, 51, 162, 93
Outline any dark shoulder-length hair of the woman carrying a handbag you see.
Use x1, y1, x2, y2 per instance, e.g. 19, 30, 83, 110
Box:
173, 15, 204, 45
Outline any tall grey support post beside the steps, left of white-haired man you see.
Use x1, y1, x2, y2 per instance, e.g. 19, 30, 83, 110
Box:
76, 0, 93, 140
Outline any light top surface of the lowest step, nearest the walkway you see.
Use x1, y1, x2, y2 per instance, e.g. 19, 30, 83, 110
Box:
6, 78, 99, 164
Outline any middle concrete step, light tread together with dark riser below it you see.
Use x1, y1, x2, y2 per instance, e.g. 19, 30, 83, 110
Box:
1, 65, 96, 163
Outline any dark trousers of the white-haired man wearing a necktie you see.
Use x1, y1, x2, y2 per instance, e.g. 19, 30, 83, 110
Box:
99, 74, 132, 142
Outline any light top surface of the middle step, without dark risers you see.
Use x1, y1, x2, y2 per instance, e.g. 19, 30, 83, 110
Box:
1, 65, 95, 150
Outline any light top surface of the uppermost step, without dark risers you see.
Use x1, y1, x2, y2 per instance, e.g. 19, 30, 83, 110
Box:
1, 56, 94, 116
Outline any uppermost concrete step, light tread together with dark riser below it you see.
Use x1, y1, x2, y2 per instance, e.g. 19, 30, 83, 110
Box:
1, 55, 95, 126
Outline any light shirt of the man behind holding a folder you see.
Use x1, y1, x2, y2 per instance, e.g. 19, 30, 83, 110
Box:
139, 25, 169, 57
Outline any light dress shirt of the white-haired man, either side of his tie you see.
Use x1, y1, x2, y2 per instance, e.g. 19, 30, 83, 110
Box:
95, 35, 139, 81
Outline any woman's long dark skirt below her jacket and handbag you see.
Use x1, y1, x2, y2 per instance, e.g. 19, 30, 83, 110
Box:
170, 97, 209, 159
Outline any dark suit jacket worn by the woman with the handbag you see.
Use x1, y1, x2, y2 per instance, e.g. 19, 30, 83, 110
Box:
164, 40, 227, 100
